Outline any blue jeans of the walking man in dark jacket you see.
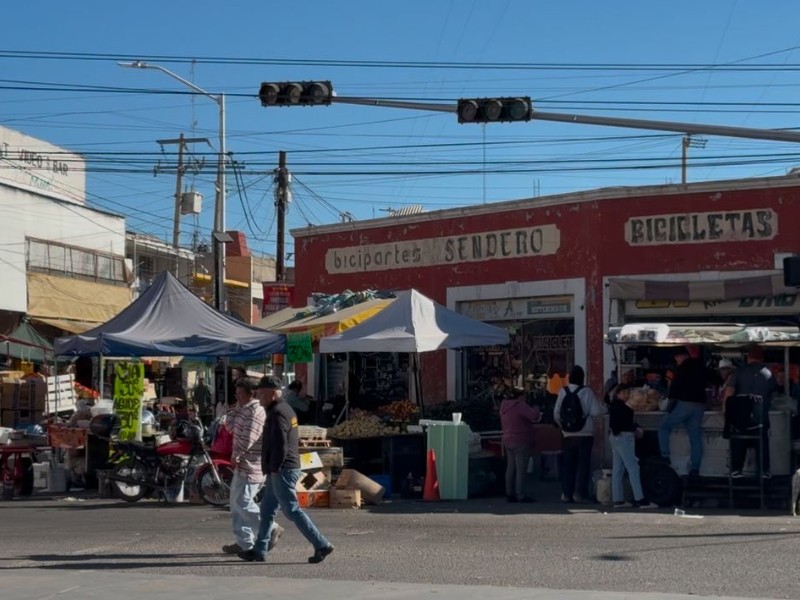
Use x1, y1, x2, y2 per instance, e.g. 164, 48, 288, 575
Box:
253, 469, 331, 555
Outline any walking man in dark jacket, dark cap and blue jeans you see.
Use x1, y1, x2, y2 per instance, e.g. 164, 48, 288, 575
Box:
239, 376, 333, 563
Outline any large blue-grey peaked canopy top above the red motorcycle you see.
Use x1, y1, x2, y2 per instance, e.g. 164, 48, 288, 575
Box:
55, 272, 286, 358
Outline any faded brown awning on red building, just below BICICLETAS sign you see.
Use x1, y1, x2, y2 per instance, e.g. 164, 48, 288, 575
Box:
608, 274, 797, 302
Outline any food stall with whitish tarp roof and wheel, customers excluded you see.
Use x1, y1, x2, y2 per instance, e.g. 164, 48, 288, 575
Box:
604, 323, 800, 504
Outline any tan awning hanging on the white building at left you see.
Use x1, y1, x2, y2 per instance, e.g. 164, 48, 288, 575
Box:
28, 273, 131, 325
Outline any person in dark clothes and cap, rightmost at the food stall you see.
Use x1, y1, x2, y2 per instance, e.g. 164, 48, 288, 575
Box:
725, 346, 778, 479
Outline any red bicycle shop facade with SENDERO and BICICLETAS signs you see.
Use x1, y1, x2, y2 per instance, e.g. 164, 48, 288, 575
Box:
292, 176, 800, 399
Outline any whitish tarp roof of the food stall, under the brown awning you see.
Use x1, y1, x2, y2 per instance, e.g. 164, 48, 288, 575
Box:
606, 323, 800, 346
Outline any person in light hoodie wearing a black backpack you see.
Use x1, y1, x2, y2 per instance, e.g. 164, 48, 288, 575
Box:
553, 365, 605, 504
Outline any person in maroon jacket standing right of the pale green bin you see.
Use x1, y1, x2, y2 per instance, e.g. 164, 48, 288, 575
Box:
500, 390, 542, 502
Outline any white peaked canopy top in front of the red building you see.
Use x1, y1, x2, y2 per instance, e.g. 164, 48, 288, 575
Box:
319, 290, 509, 352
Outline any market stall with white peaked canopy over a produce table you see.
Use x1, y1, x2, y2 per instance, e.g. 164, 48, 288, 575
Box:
320, 290, 509, 497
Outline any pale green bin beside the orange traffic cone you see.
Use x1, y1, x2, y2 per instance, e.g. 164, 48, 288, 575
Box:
428, 423, 469, 500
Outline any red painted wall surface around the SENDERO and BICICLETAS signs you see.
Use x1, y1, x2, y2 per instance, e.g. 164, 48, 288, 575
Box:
295, 178, 800, 397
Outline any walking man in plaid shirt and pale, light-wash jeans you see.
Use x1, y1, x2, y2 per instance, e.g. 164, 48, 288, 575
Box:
222, 378, 282, 554
